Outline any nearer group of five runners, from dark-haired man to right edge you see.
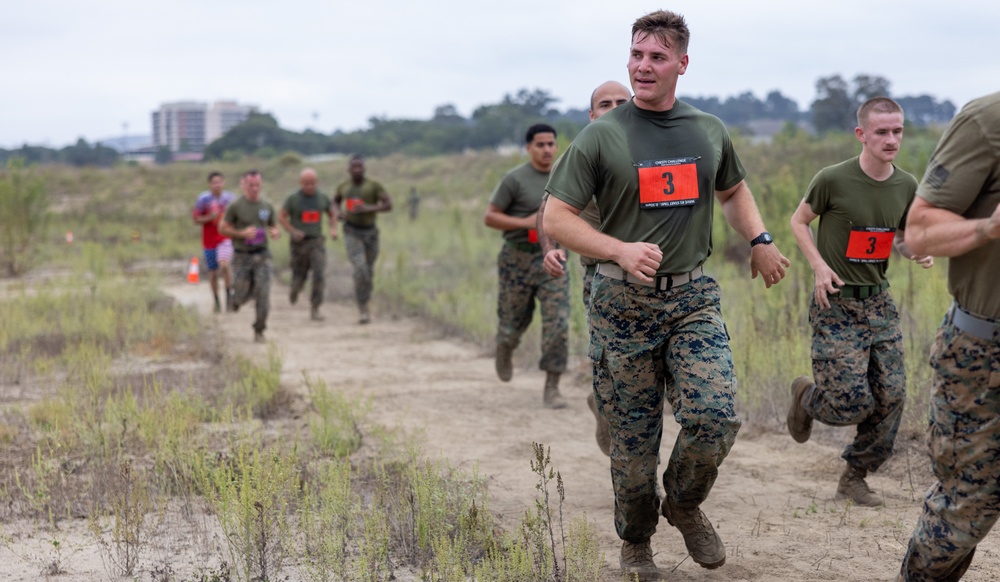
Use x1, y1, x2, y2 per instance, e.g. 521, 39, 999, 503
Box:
484, 11, 1000, 582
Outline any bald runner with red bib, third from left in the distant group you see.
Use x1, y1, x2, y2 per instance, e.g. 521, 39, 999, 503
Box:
278, 168, 337, 321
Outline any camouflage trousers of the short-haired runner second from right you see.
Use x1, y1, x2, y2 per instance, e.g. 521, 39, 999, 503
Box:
803, 292, 906, 471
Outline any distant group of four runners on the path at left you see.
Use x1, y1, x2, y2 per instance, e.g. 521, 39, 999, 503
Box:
192, 156, 392, 342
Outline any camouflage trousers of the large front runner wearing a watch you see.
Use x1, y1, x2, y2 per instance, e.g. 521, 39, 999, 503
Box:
590, 275, 740, 542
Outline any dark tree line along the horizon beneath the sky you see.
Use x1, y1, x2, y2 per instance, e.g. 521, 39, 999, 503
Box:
0, 74, 956, 166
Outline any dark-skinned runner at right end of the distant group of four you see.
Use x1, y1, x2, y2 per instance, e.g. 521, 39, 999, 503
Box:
333, 155, 392, 323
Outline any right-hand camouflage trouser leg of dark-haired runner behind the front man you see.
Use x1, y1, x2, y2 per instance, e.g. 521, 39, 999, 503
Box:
531, 259, 569, 374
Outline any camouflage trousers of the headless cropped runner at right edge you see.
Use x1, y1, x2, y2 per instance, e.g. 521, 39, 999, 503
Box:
903, 315, 1000, 582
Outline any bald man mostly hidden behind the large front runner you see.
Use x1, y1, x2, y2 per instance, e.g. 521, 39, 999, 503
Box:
538, 81, 632, 455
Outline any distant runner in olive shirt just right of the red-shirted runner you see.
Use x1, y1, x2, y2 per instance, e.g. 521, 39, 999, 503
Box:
219, 170, 280, 343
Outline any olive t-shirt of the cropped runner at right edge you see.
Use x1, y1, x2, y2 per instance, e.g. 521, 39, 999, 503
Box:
917, 93, 1000, 319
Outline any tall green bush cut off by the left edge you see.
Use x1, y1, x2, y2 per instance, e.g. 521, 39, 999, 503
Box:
0, 158, 49, 277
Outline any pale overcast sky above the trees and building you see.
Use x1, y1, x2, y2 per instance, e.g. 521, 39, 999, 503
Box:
0, 0, 1000, 148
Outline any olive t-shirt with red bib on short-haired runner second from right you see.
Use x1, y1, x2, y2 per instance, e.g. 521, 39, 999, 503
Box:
805, 157, 917, 285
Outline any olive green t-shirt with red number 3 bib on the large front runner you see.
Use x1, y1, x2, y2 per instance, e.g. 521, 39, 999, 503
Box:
546, 101, 745, 275
